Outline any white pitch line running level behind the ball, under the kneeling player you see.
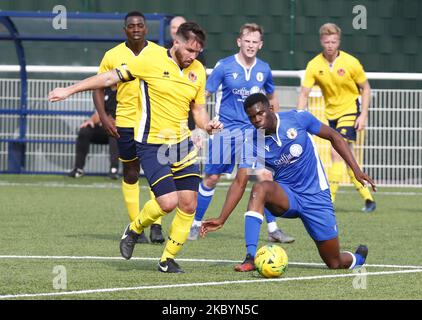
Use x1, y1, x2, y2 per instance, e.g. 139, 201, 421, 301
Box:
0, 255, 422, 269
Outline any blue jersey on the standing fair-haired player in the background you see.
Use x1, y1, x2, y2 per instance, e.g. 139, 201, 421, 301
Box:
206, 55, 274, 129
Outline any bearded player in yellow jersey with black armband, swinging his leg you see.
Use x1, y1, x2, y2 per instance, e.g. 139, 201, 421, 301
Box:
48, 22, 223, 273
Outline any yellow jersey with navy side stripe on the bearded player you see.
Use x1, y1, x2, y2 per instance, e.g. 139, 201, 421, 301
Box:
118, 42, 206, 144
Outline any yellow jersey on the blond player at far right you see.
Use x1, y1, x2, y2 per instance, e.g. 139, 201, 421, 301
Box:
302, 51, 366, 120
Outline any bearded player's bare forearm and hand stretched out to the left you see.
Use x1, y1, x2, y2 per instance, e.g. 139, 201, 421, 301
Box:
48, 70, 120, 102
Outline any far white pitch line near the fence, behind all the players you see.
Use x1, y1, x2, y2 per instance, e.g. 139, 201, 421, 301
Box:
0, 181, 422, 196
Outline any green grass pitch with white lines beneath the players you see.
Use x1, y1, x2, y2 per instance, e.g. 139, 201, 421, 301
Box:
0, 175, 422, 300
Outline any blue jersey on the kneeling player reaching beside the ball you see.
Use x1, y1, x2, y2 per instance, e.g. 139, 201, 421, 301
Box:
265, 110, 329, 194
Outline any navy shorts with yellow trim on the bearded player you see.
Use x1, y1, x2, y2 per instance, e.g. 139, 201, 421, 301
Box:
136, 139, 201, 197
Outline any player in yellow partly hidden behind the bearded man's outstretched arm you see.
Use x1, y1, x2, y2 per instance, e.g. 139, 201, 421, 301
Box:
93, 11, 164, 243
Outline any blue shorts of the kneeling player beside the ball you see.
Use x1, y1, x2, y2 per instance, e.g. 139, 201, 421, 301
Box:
279, 183, 338, 241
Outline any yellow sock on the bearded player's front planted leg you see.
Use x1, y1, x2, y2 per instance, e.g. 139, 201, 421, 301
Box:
161, 208, 195, 261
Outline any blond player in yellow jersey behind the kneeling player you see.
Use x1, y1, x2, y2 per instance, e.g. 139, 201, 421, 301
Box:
298, 23, 376, 212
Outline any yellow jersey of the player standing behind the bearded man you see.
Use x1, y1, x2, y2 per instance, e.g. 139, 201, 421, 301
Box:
98, 42, 145, 128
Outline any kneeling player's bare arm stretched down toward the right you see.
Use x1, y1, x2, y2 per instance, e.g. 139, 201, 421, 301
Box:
318, 124, 377, 192
